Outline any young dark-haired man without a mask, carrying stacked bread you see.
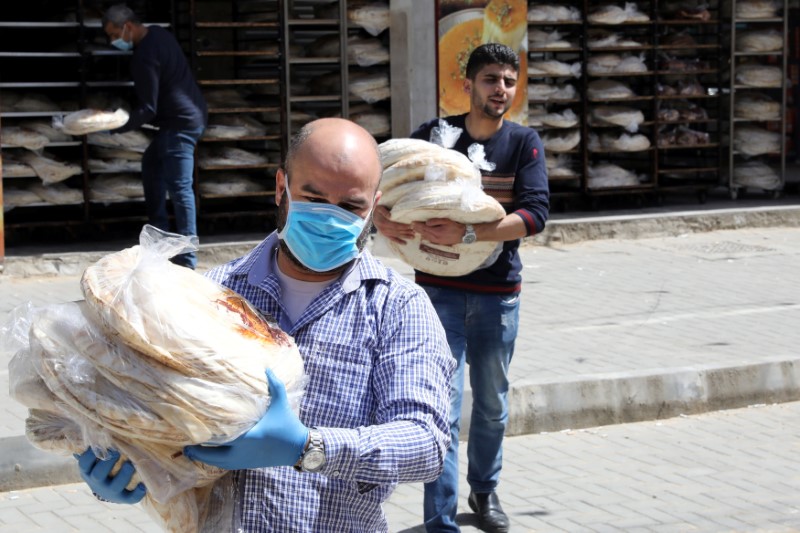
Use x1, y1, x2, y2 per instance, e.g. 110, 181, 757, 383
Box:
374, 43, 550, 532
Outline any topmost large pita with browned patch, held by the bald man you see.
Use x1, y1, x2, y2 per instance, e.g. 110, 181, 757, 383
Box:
81, 245, 303, 392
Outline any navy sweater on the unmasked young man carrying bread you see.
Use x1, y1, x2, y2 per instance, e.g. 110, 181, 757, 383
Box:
411, 114, 550, 294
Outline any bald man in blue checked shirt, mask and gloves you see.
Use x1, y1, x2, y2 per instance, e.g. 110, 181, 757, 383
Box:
79, 118, 455, 533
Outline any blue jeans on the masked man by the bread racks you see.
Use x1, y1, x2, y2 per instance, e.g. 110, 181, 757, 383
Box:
142, 123, 204, 269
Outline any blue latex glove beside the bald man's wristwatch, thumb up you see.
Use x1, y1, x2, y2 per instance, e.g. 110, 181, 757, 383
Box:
183, 370, 308, 470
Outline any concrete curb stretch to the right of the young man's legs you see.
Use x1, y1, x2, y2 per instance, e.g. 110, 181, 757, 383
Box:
504, 356, 800, 435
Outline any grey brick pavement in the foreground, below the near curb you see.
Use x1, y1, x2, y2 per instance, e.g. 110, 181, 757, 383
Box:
0, 402, 800, 533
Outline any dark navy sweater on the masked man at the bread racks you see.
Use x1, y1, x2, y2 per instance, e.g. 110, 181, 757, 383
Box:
114, 26, 208, 133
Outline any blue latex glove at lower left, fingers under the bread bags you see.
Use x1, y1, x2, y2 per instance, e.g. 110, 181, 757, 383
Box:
75, 448, 147, 503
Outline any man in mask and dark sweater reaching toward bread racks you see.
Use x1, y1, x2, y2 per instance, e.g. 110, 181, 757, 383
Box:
103, 4, 208, 269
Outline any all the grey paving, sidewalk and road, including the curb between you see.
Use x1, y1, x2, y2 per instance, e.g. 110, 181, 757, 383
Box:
0, 214, 800, 532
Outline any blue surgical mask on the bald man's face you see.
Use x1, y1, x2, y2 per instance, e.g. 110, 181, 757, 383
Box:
278, 187, 369, 272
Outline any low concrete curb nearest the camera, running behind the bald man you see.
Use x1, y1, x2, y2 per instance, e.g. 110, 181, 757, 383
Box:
6, 356, 800, 492
